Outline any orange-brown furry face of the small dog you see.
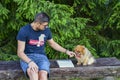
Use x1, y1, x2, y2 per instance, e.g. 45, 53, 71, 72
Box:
74, 45, 85, 56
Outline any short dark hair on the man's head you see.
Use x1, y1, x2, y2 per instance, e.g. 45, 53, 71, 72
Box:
34, 12, 50, 23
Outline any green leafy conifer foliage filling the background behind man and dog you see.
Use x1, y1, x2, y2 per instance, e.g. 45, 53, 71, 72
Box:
0, 0, 120, 60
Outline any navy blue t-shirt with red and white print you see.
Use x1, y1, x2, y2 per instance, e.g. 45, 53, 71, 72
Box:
17, 24, 52, 55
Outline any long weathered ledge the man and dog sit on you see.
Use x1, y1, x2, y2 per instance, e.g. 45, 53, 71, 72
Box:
0, 57, 120, 80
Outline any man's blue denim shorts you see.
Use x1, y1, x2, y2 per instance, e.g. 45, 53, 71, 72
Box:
20, 54, 50, 77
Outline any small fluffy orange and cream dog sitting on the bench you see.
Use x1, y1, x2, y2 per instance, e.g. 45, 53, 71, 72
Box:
74, 45, 96, 65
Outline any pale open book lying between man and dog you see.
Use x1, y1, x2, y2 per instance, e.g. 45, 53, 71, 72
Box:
57, 60, 74, 67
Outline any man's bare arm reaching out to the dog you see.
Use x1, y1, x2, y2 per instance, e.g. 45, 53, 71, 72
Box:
48, 39, 75, 57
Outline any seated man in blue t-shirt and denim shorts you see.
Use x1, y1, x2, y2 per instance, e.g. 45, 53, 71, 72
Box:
17, 12, 75, 80
